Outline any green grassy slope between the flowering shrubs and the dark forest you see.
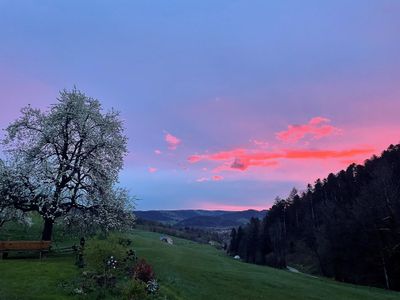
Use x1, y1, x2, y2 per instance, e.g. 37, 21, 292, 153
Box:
130, 231, 400, 300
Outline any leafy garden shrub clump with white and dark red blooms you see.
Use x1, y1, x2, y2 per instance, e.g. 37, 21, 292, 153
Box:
63, 234, 161, 300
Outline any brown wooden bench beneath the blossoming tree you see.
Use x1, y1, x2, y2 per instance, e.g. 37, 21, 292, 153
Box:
0, 241, 51, 259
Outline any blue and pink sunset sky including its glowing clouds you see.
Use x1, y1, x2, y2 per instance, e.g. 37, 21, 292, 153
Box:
0, 0, 400, 210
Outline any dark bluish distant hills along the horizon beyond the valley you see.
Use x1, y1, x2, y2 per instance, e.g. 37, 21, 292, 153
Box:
135, 209, 266, 228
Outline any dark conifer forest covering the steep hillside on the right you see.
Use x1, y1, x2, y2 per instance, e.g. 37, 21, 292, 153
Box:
228, 145, 400, 290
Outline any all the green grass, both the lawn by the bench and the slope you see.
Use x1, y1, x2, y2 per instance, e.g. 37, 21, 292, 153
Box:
0, 230, 400, 300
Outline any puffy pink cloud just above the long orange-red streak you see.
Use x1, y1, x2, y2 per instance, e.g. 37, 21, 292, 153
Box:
276, 117, 341, 143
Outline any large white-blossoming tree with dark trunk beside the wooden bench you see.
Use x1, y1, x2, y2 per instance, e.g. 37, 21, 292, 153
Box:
1, 89, 131, 240
